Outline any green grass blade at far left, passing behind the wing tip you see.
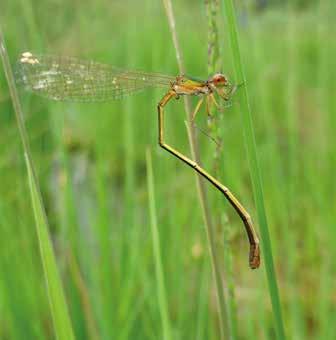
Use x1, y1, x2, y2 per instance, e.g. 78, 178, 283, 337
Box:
0, 28, 74, 340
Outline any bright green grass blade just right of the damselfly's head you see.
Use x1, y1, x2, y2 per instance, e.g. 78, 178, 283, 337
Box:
223, 0, 285, 340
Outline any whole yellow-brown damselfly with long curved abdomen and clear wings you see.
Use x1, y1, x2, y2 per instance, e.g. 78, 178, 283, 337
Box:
18, 52, 260, 269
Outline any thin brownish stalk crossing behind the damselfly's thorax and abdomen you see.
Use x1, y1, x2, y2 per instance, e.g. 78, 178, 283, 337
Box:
163, 0, 228, 340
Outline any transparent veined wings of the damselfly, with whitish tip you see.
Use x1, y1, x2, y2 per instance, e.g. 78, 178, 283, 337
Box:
17, 52, 176, 102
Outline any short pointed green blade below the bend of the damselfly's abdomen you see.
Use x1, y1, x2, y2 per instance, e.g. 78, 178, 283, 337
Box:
146, 148, 172, 340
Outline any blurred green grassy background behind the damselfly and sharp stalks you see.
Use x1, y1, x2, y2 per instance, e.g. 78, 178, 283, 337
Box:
0, 0, 336, 340
